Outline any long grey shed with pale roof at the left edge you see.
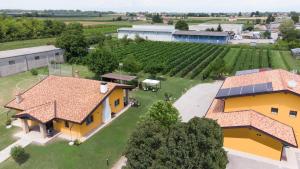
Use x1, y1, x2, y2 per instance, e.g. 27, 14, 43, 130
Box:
0, 45, 64, 77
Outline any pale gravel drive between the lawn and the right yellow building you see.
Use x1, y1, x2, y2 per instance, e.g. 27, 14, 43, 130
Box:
174, 81, 223, 122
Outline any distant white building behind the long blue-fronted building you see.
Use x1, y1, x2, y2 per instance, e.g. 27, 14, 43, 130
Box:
189, 23, 243, 35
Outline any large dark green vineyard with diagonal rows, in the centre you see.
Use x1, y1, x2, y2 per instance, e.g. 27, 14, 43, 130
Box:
114, 42, 230, 79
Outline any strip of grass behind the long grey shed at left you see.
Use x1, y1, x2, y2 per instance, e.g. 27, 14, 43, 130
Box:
0, 38, 55, 51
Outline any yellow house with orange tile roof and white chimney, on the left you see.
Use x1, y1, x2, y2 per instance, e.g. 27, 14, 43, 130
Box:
5, 76, 131, 139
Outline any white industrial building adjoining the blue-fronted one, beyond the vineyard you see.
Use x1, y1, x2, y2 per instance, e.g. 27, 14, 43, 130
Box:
118, 25, 175, 41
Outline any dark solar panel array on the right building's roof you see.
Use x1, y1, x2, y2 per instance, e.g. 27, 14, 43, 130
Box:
216, 82, 273, 98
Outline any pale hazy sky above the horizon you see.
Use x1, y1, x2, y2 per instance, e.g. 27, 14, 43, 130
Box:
0, 0, 300, 12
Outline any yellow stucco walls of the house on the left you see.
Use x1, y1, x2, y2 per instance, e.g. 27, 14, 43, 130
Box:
53, 89, 124, 139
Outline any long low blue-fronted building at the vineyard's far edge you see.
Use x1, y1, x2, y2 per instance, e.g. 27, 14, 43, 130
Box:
173, 31, 229, 44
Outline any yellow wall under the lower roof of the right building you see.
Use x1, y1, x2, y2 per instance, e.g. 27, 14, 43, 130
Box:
223, 128, 282, 160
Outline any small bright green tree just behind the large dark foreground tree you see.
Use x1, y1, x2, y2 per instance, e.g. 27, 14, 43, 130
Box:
146, 101, 180, 127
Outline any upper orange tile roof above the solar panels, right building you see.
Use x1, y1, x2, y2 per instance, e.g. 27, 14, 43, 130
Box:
221, 69, 300, 94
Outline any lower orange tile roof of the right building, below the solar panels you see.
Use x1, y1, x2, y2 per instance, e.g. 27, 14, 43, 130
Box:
206, 99, 297, 147
